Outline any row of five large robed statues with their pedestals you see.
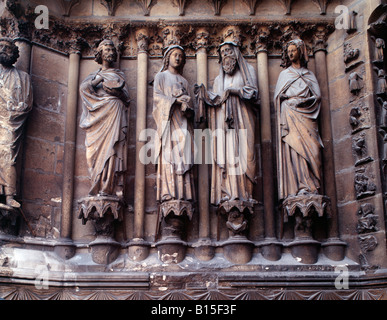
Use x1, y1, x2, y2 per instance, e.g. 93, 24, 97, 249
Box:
0, 35, 329, 263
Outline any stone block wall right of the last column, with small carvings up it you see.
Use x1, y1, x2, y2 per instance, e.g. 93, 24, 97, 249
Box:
327, 1, 386, 265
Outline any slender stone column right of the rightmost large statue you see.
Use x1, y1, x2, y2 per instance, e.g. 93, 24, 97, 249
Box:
313, 26, 346, 261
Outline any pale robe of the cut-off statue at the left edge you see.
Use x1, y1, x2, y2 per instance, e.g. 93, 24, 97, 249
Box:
0, 66, 32, 196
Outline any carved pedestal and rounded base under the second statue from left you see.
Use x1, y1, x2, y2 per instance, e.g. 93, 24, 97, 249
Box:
78, 196, 123, 264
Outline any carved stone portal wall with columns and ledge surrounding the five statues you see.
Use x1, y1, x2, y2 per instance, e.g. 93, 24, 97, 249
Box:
0, 0, 387, 299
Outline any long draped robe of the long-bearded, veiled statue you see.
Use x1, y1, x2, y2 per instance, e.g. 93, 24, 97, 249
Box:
206, 62, 258, 205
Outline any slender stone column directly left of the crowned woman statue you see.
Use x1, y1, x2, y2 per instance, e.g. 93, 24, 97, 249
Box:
129, 29, 149, 261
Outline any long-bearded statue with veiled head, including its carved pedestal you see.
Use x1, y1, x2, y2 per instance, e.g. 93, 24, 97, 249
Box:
195, 41, 258, 246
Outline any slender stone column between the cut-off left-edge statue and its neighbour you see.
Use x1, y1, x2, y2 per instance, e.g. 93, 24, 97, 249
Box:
55, 46, 81, 259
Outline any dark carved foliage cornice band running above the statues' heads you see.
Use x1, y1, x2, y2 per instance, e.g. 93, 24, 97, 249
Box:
0, 2, 334, 58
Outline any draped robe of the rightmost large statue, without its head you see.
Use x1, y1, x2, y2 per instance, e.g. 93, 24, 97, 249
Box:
274, 67, 323, 199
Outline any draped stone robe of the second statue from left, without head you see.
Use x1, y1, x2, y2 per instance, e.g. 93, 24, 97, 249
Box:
80, 68, 129, 195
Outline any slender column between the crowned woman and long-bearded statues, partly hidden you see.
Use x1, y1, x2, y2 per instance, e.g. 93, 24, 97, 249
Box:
195, 28, 215, 260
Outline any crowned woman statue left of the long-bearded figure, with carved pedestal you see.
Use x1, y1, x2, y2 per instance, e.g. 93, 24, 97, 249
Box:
153, 45, 195, 248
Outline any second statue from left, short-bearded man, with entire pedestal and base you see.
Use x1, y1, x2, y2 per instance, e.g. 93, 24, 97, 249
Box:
78, 40, 129, 264
